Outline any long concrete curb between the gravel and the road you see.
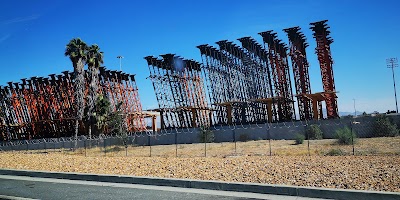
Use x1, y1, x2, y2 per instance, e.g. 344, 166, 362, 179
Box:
0, 169, 400, 200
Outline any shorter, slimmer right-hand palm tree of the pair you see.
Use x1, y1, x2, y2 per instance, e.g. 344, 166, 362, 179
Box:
87, 44, 103, 139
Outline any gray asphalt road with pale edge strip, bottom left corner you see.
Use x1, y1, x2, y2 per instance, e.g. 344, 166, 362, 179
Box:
0, 175, 332, 200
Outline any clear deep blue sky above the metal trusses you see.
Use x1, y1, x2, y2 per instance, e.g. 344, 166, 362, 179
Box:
0, 0, 400, 112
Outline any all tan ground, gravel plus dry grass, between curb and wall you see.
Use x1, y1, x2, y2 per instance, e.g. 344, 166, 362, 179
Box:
0, 137, 400, 192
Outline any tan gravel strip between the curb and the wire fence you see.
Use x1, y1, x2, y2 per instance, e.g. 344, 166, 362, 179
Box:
0, 153, 400, 192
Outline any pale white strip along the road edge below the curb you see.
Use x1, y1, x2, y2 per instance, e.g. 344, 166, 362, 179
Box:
0, 175, 328, 200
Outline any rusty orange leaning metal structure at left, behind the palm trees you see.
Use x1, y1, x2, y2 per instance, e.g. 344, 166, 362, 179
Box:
0, 67, 148, 141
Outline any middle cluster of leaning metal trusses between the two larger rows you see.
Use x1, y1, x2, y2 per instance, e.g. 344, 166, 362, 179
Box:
145, 54, 210, 129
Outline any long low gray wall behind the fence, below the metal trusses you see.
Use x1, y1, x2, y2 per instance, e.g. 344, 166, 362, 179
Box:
0, 115, 400, 151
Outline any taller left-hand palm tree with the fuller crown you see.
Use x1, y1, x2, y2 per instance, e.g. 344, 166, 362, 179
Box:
64, 38, 88, 148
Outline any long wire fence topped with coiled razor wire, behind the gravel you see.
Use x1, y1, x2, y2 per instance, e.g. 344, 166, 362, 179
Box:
0, 117, 400, 157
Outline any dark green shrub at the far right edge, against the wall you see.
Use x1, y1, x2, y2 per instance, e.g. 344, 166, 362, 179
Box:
373, 115, 399, 137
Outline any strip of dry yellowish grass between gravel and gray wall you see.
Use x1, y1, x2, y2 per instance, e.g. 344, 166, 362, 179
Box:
36, 137, 400, 157
